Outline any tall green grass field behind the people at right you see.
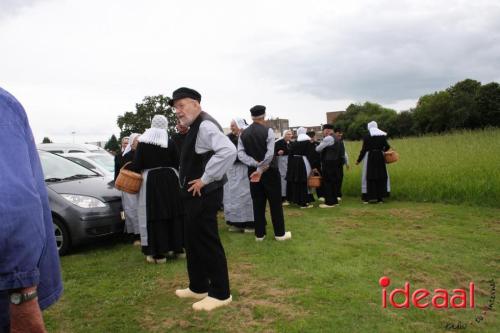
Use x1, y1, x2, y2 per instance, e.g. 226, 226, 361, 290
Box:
343, 129, 500, 207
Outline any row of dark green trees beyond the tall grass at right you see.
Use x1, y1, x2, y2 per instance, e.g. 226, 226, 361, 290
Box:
335, 79, 500, 140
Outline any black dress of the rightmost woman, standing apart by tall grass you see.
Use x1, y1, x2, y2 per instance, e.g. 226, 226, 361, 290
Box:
358, 135, 391, 201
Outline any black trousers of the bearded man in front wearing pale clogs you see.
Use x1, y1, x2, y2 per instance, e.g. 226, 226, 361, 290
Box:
184, 187, 230, 300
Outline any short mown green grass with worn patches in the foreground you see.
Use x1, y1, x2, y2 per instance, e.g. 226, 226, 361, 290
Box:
44, 198, 500, 332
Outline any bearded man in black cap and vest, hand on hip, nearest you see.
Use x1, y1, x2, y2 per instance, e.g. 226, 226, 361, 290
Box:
169, 88, 236, 311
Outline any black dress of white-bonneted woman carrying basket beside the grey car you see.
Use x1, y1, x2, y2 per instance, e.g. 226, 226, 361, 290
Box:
133, 140, 184, 257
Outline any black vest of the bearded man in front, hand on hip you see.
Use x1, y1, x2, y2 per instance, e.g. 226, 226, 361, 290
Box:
179, 111, 227, 197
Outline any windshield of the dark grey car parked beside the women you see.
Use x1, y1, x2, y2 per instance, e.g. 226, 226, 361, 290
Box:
38, 150, 98, 179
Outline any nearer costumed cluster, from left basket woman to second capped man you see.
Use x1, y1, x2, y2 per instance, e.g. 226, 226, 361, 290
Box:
115, 88, 292, 311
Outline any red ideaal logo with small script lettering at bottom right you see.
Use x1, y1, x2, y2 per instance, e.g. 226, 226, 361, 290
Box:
379, 276, 496, 329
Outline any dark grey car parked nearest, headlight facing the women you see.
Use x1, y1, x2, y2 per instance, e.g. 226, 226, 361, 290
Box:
38, 150, 124, 255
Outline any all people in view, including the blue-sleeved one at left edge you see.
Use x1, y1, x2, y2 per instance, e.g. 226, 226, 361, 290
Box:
0, 83, 390, 332
